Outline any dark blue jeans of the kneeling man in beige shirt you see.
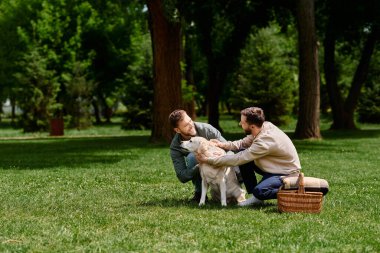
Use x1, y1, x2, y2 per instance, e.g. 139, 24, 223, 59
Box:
239, 162, 284, 200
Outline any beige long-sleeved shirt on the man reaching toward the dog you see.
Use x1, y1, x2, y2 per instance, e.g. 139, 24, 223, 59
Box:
208, 121, 301, 175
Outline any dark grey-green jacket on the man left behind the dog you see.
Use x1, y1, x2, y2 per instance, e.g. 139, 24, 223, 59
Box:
170, 122, 226, 183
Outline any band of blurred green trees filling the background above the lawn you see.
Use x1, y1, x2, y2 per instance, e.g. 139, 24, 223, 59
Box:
0, 0, 380, 140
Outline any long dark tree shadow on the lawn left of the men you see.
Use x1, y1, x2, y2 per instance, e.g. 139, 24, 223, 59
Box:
0, 136, 162, 169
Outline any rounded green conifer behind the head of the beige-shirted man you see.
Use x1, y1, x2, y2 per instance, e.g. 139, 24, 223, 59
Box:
229, 25, 297, 124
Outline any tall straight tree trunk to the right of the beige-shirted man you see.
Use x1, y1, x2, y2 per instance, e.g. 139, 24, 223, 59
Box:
295, 0, 321, 139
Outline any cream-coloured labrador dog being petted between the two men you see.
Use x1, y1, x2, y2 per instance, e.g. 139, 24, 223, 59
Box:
181, 137, 245, 206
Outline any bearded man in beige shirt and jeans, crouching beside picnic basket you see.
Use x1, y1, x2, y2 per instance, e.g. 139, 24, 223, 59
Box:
197, 107, 301, 206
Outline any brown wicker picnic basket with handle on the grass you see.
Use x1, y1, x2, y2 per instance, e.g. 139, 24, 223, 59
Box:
277, 173, 323, 213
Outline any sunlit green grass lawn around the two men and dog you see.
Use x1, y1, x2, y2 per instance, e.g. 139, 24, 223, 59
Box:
0, 117, 380, 252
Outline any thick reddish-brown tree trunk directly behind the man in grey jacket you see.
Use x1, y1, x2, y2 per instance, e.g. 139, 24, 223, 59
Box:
147, 0, 182, 142
